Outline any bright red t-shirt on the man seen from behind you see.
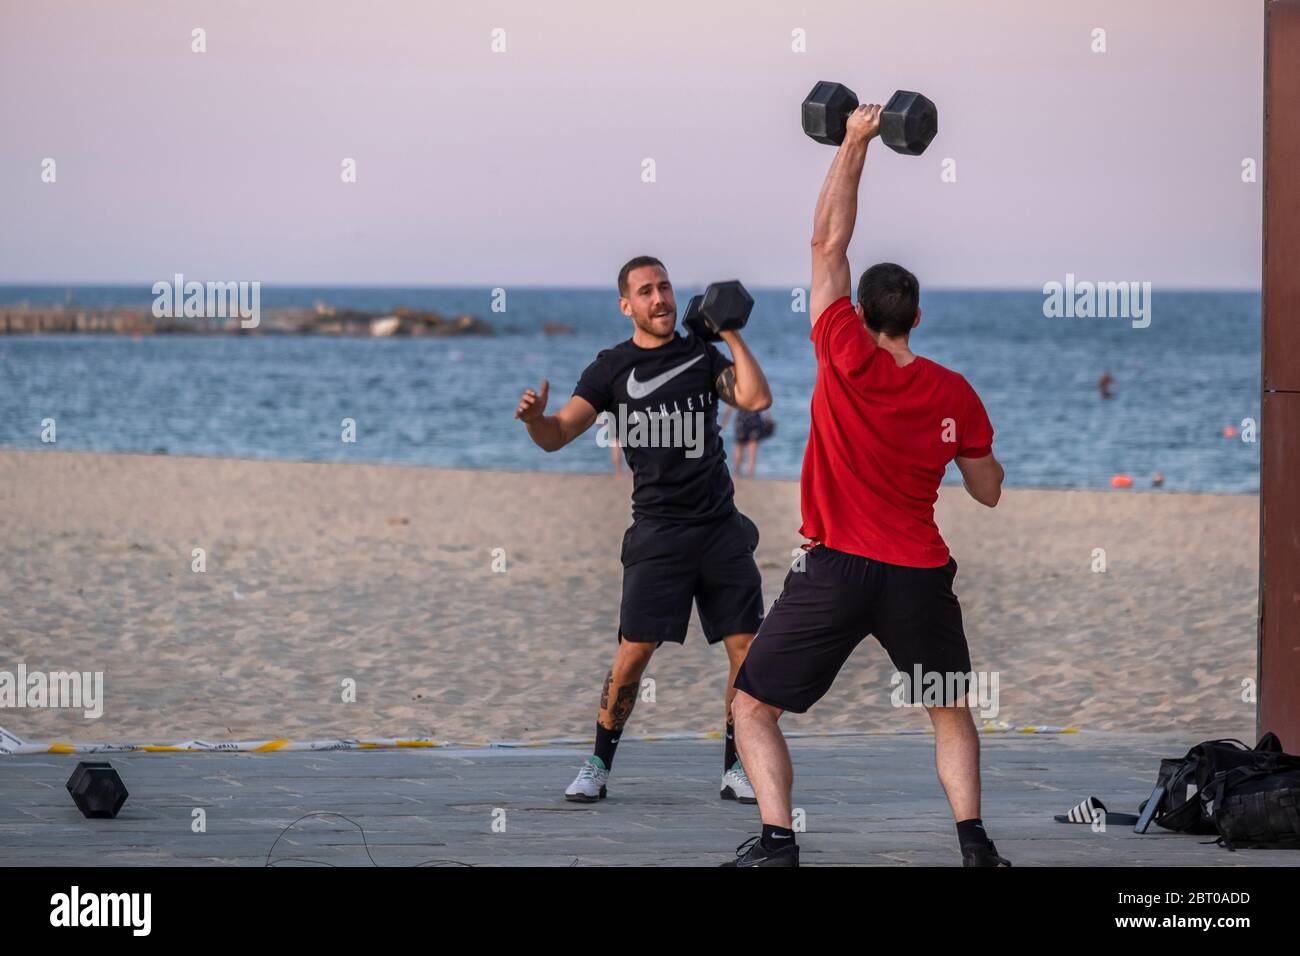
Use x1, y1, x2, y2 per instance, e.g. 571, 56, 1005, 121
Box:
800, 295, 993, 567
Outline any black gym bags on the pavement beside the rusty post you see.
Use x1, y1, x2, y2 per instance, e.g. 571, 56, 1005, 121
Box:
1139, 732, 1300, 849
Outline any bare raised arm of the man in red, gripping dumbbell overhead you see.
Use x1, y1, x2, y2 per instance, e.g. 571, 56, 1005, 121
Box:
809, 103, 880, 325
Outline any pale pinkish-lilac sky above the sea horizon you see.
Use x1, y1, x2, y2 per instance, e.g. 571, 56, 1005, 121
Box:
0, 0, 1264, 287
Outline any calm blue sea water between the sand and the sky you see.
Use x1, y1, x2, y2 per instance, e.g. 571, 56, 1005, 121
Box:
0, 286, 1260, 493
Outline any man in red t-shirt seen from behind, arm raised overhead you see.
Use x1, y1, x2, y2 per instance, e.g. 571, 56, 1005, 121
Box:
724, 104, 1010, 866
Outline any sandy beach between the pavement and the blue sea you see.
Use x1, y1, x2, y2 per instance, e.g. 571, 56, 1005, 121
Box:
0, 450, 1258, 743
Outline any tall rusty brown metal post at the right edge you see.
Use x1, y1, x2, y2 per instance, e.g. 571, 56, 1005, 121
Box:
1256, 0, 1300, 753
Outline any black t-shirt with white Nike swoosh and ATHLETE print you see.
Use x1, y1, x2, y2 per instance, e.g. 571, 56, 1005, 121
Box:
573, 334, 736, 524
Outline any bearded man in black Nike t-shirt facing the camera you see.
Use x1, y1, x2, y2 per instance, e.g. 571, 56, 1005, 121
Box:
515, 256, 772, 804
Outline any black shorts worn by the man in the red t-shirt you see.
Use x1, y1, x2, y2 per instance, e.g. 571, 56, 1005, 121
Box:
736, 545, 971, 714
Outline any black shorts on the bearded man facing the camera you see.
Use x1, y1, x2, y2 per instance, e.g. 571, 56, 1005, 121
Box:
619, 511, 763, 644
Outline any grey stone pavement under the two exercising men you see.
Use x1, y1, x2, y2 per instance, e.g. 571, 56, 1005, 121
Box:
0, 734, 1300, 866
